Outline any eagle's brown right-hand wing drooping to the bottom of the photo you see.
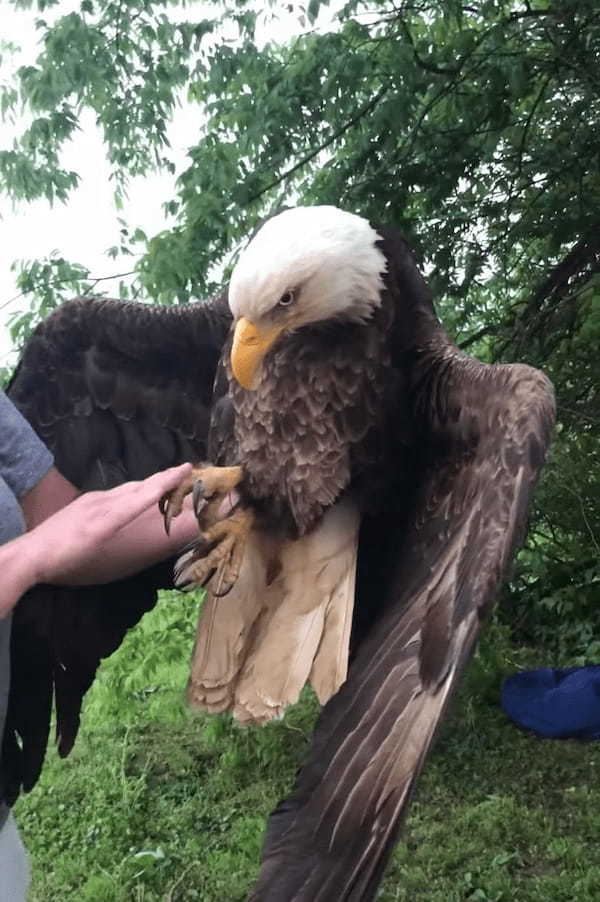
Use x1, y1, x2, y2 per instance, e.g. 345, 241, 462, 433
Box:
250, 296, 554, 902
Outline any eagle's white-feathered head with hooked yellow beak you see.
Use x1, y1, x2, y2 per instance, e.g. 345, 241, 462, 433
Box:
229, 207, 386, 388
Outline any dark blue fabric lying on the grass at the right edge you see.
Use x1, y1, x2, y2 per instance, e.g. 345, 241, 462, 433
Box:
501, 665, 600, 739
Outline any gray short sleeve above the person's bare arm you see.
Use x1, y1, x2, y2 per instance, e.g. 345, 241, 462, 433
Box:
0, 391, 54, 498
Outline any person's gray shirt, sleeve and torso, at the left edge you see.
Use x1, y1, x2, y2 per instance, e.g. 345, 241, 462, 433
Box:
0, 391, 53, 829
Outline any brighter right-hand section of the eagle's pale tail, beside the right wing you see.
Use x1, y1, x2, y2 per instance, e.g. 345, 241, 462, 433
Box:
234, 501, 359, 722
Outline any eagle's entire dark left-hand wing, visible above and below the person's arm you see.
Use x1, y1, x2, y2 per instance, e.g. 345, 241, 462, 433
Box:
2, 297, 230, 802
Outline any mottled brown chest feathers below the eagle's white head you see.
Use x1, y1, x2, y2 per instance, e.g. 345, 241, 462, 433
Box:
220, 310, 392, 535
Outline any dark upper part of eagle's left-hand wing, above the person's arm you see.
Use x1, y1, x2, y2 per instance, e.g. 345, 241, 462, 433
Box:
8, 298, 229, 490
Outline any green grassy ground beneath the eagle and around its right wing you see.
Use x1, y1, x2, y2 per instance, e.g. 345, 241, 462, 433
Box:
12, 597, 600, 902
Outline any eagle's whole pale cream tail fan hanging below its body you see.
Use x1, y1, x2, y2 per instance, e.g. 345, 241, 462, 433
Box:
188, 501, 359, 723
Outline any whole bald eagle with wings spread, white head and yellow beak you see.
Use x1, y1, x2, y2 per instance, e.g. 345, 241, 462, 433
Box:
3, 207, 554, 902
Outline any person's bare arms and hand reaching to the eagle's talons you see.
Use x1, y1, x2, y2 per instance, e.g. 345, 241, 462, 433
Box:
0, 464, 197, 617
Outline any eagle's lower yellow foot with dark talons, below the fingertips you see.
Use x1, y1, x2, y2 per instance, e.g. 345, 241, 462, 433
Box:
175, 508, 254, 597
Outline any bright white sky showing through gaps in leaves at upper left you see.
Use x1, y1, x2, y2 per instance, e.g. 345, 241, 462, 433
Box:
0, 0, 342, 365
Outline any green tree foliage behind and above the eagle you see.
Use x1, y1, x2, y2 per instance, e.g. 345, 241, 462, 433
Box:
0, 0, 600, 654
